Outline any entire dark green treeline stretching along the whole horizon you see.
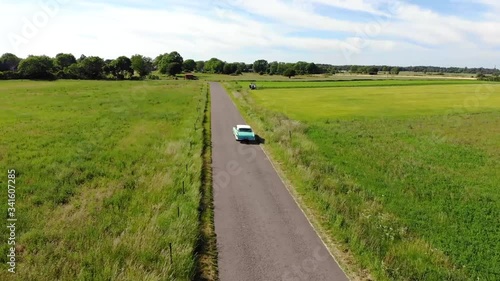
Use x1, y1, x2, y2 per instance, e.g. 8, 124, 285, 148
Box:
0, 51, 498, 80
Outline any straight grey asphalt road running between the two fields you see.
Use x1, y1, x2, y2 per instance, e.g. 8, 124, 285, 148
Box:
210, 83, 348, 281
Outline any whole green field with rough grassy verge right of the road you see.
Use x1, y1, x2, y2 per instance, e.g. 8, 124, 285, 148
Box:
226, 81, 500, 280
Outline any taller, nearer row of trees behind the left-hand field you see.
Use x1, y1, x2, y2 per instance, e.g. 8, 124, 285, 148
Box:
0, 51, 210, 80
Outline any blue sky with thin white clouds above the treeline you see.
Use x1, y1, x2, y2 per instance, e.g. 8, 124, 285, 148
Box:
0, 0, 500, 68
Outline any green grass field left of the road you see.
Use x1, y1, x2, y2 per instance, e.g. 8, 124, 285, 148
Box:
0, 81, 208, 280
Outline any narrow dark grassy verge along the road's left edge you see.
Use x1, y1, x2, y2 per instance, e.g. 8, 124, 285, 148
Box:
195, 83, 218, 281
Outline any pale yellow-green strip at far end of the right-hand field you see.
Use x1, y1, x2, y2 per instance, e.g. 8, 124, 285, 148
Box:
253, 81, 500, 121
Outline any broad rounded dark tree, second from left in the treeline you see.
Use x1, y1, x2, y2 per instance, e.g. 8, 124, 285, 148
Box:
19, 56, 55, 80
